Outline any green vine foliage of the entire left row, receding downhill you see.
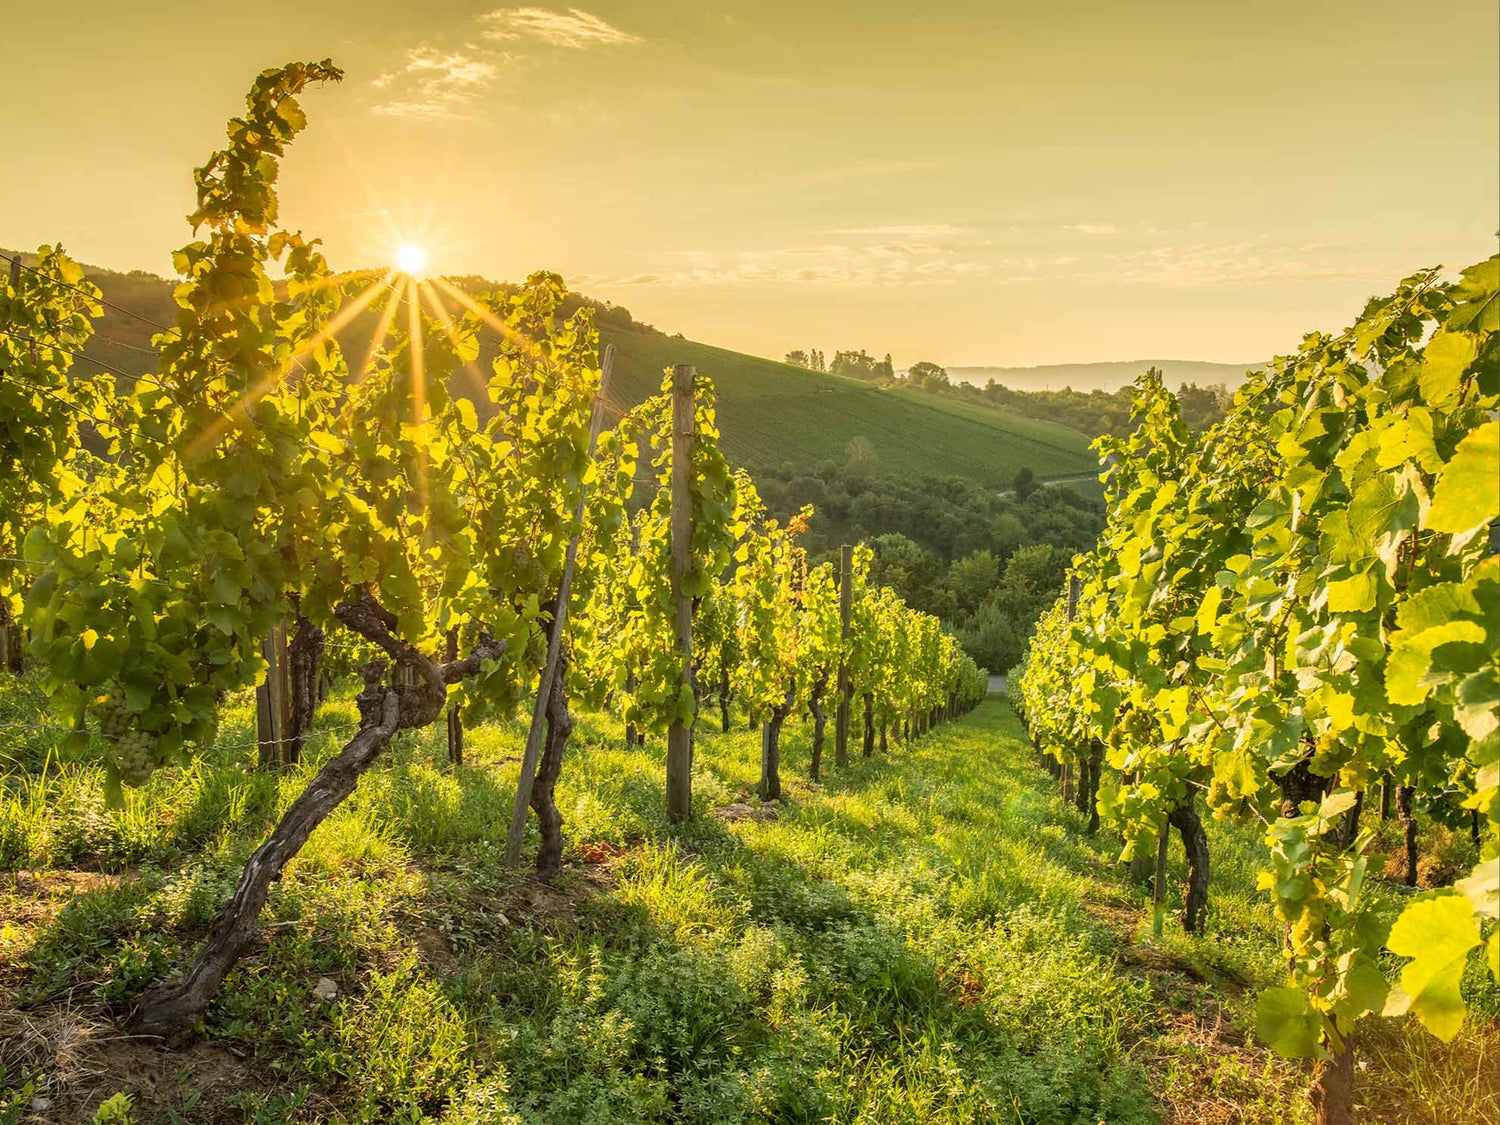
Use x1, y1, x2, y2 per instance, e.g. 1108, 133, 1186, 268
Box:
11, 62, 983, 822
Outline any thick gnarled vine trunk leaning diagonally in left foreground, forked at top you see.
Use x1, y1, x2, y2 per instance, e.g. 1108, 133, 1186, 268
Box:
126, 594, 504, 1035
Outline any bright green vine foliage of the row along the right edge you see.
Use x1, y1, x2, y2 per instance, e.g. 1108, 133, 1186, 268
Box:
1017, 258, 1500, 1058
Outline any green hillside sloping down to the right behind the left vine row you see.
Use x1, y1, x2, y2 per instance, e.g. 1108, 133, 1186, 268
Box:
6, 251, 1095, 486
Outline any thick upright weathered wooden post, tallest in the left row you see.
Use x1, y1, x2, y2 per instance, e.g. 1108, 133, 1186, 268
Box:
666, 363, 696, 821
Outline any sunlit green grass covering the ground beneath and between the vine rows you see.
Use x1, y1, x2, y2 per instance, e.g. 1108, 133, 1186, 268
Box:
0, 678, 1497, 1125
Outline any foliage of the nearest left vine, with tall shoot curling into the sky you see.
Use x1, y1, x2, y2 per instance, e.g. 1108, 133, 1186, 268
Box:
26, 63, 600, 795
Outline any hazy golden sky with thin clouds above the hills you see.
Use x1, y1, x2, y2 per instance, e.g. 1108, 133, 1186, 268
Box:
0, 0, 1500, 366
